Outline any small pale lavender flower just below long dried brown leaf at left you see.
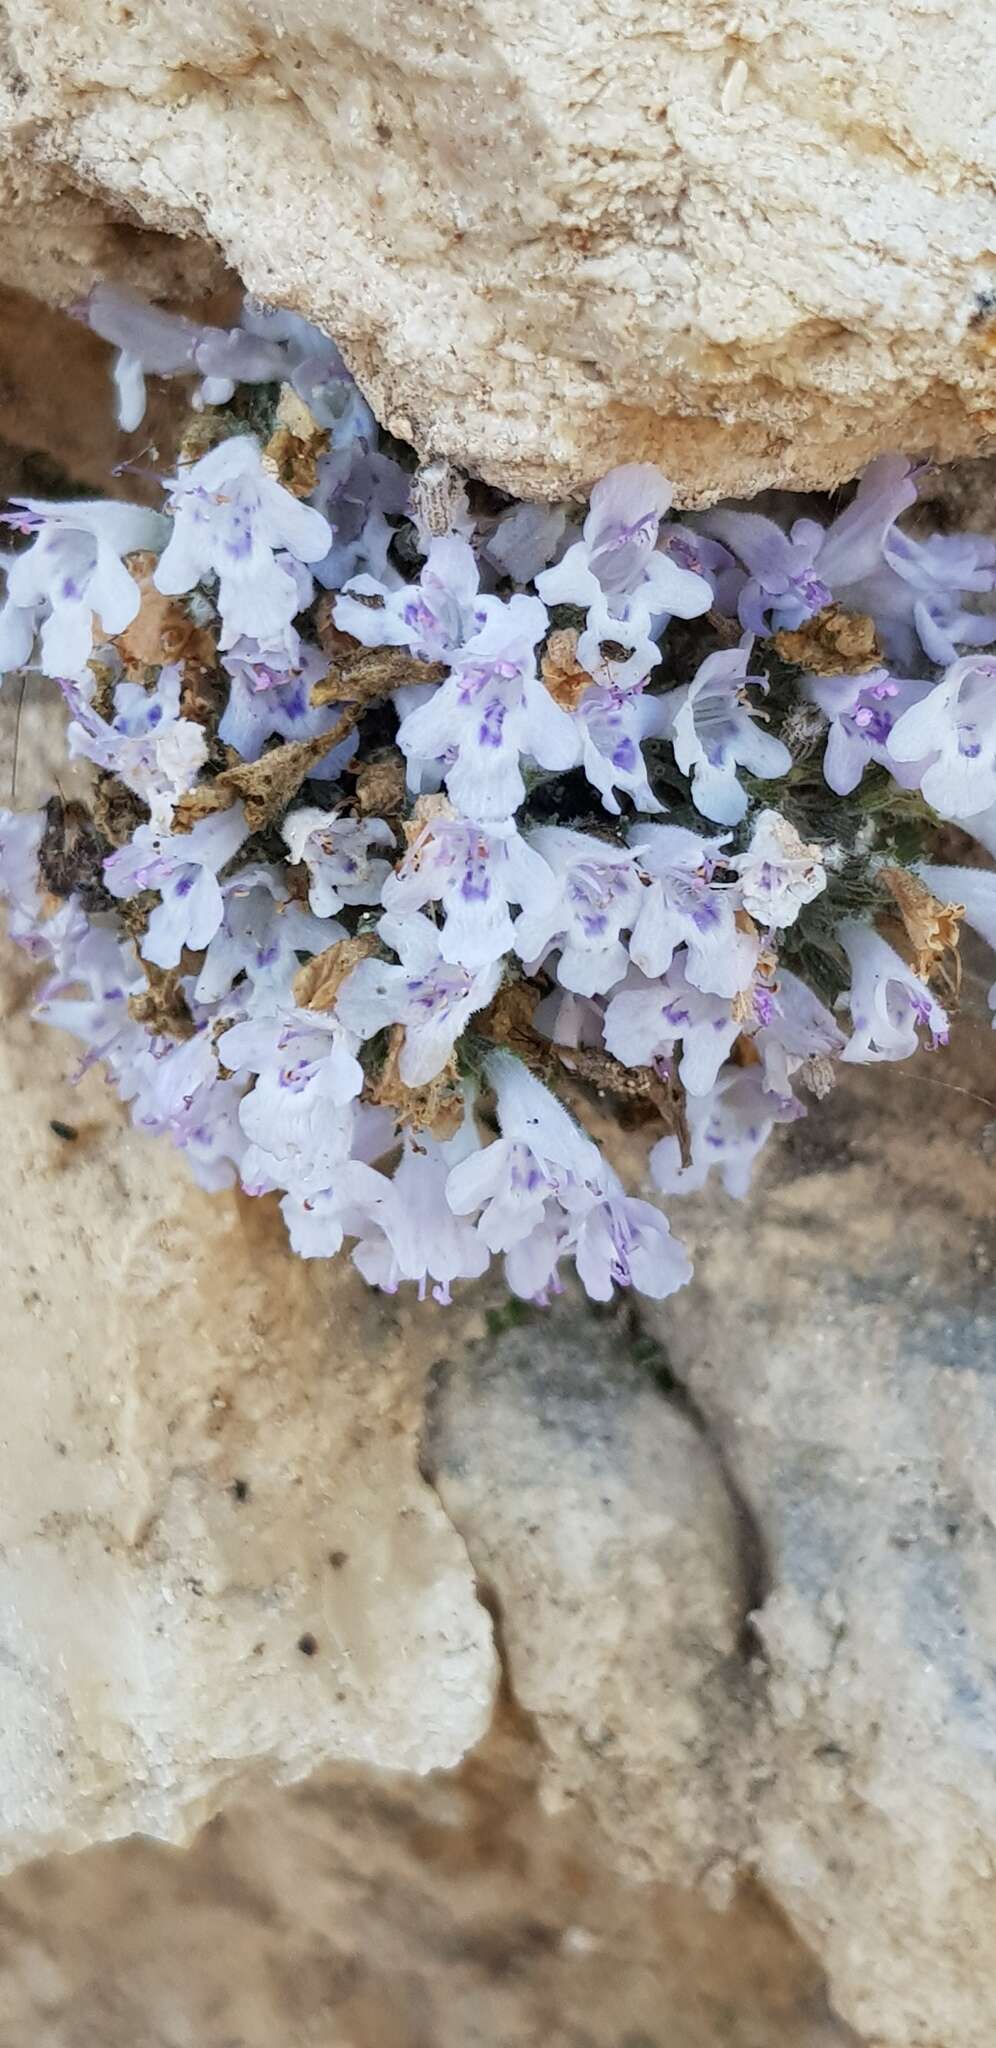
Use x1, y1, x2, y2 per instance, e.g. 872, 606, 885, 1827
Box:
105, 803, 248, 967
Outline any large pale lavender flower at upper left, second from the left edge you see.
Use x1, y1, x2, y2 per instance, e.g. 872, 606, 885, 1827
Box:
154, 434, 332, 647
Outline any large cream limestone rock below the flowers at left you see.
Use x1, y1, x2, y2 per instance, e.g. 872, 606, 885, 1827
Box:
0, 888, 496, 1868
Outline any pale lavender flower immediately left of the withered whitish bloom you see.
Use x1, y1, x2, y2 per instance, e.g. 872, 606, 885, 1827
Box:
629, 825, 758, 995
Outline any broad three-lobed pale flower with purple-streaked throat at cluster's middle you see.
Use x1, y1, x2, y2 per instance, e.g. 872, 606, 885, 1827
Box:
383, 799, 557, 973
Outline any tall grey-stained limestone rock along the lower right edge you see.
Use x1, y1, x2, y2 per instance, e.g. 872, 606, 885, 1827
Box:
656, 977, 996, 2048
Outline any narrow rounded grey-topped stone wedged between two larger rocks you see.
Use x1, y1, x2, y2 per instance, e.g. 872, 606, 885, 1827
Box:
424, 1305, 746, 1896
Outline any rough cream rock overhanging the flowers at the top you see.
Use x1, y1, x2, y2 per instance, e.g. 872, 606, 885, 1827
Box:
0, 0, 996, 504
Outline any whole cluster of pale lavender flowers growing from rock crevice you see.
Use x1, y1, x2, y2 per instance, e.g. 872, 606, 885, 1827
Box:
0, 287, 996, 1300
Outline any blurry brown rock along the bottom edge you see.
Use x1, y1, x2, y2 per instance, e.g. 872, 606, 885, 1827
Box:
0, 1712, 857, 2048
